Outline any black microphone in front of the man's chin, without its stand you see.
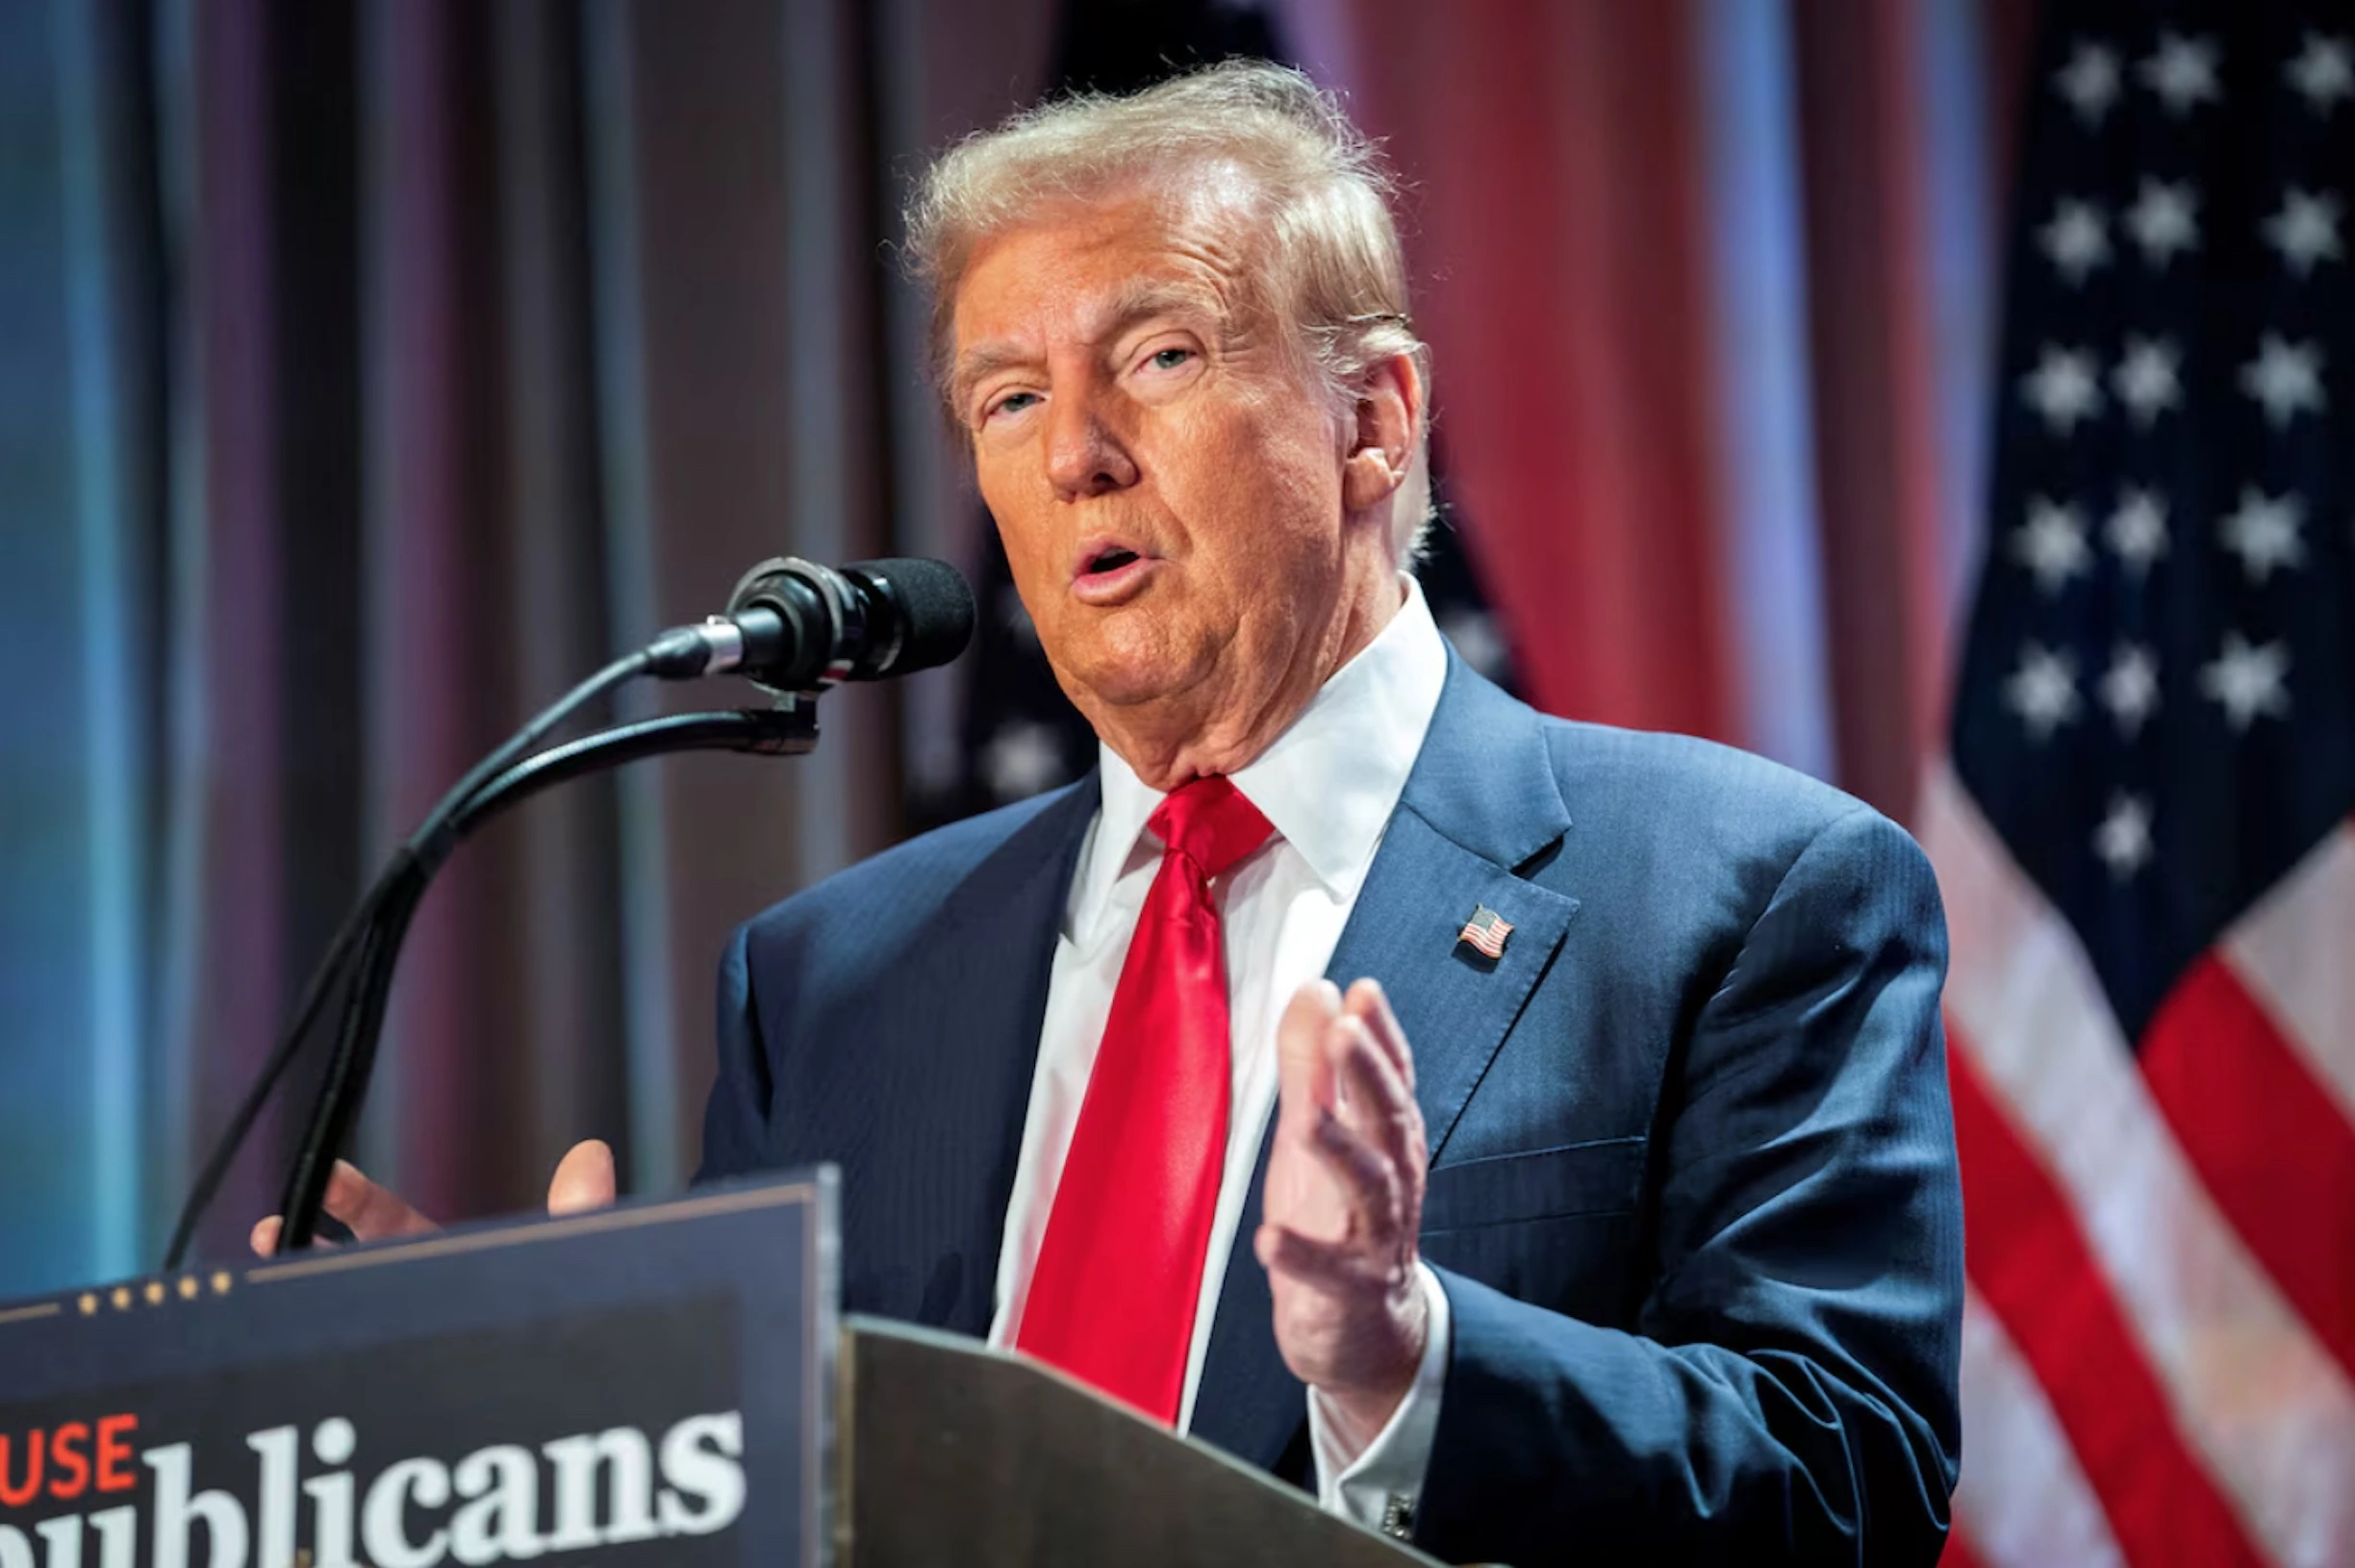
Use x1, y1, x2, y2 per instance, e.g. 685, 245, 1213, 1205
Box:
646, 556, 975, 693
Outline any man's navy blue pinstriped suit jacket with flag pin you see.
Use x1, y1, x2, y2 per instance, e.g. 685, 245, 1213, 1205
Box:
704, 657, 1962, 1568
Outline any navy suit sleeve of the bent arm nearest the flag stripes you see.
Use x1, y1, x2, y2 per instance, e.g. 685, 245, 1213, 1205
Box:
1415, 807, 1962, 1568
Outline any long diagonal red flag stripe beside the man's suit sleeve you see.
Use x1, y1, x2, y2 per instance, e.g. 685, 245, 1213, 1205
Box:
1947, 1015, 2264, 1568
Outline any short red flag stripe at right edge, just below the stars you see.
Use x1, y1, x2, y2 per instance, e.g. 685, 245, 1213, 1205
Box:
2140, 953, 2355, 1373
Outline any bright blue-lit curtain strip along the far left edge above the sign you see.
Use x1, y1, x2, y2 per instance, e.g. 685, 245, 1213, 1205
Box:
0, 5, 167, 1288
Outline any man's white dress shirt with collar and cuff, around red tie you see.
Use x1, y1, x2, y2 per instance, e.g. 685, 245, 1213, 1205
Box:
989, 577, 1449, 1528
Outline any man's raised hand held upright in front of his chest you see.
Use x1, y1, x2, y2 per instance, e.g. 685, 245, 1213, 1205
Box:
1253, 979, 1430, 1446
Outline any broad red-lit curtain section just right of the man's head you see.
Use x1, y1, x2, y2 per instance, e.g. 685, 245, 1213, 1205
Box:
1358, 0, 1735, 735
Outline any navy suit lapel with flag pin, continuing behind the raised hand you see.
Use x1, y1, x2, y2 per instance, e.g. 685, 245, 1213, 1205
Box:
1194, 652, 1578, 1469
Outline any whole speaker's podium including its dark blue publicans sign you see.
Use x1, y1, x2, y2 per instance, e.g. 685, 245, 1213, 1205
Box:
0, 1168, 1430, 1568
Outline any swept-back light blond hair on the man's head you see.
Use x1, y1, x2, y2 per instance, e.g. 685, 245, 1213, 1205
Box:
906, 62, 1431, 565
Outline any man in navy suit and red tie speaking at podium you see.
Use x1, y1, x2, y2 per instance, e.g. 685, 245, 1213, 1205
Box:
285, 66, 1962, 1566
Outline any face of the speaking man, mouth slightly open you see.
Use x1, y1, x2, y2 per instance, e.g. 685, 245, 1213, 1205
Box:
951, 195, 1397, 786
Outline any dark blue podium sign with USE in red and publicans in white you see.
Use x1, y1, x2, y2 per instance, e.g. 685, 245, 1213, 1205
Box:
0, 1168, 836, 1568
